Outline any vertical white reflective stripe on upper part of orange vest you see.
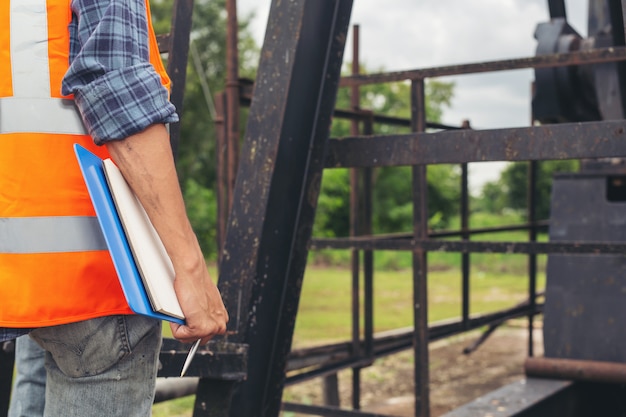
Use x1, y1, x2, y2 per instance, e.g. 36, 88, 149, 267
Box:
9, 0, 50, 97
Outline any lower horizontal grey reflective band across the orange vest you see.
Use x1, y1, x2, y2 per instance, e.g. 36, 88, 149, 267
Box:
0, 216, 107, 254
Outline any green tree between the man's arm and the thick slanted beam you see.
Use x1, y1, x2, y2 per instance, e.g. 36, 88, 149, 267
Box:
150, 0, 259, 258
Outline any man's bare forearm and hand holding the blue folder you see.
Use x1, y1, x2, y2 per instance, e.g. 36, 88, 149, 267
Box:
106, 121, 228, 343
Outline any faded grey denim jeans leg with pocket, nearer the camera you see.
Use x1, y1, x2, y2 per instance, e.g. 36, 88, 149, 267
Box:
30, 316, 161, 417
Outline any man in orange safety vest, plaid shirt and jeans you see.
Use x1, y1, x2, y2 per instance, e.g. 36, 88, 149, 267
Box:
0, 0, 228, 417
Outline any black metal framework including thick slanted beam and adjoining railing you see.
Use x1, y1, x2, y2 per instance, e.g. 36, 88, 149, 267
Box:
0, 0, 626, 417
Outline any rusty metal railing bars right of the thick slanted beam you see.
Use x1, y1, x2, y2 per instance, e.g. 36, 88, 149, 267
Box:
206, 0, 626, 416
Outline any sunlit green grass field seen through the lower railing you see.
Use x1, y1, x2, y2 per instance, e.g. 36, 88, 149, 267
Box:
153, 262, 545, 417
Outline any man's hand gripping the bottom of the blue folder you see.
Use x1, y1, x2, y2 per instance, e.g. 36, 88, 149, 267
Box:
170, 261, 228, 345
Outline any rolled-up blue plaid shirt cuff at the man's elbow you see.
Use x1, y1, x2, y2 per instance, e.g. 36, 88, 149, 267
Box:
74, 63, 178, 145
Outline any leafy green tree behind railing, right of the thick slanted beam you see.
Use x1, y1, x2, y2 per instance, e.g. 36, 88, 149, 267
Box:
314, 63, 460, 237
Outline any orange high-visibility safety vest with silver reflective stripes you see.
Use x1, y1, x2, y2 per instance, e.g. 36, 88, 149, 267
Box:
0, 0, 169, 328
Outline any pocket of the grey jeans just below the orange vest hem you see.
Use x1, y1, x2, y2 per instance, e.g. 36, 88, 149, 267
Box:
31, 316, 131, 378
